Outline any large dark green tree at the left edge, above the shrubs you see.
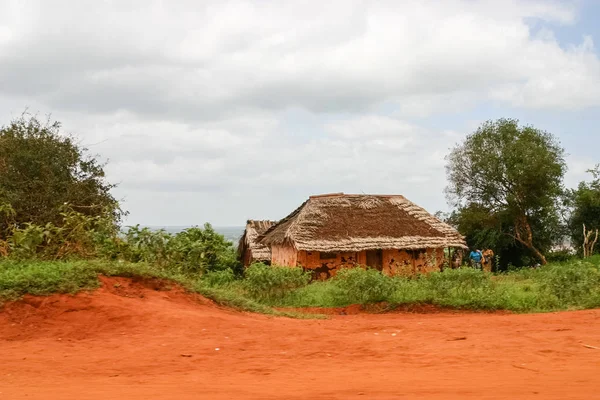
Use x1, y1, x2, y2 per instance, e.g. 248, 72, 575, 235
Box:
0, 114, 124, 238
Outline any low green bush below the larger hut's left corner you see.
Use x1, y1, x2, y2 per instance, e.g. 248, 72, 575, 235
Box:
245, 263, 311, 301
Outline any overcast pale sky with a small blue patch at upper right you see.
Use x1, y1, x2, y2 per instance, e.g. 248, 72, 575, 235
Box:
0, 0, 600, 226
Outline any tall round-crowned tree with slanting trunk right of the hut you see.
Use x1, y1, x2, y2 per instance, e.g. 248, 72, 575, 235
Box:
446, 119, 566, 264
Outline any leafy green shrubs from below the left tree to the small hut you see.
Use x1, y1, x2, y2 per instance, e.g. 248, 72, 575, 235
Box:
0, 214, 240, 275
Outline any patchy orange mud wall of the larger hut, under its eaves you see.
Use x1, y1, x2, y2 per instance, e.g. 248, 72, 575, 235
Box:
290, 245, 444, 279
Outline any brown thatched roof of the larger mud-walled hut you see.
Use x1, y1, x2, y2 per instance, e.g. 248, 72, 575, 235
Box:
259, 193, 467, 252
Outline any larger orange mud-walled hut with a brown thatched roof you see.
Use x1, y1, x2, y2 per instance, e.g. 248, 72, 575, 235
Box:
259, 193, 466, 273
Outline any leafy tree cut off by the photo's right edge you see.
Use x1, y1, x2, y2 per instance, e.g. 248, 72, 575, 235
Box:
569, 165, 600, 255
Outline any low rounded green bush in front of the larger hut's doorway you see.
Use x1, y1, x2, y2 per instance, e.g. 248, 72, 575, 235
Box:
333, 268, 394, 304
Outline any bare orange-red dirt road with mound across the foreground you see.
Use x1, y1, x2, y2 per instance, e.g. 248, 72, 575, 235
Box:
0, 278, 600, 400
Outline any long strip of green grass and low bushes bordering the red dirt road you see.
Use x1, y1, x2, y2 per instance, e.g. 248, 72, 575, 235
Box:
0, 257, 600, 315
